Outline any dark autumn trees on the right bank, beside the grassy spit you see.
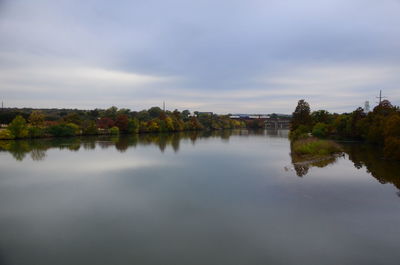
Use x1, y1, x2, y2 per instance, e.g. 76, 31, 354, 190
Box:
290, 99, 400, 160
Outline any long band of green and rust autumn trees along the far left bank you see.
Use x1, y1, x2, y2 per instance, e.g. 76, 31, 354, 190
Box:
0, 106, 246, 139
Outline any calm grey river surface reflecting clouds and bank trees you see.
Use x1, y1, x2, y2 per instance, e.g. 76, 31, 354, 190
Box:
0, 131, 400, 265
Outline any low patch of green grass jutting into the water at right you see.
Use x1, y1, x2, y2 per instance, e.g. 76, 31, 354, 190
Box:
292, 137, 342, 157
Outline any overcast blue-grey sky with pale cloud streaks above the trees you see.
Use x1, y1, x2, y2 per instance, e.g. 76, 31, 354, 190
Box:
0, 0, 400, 114
